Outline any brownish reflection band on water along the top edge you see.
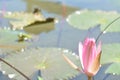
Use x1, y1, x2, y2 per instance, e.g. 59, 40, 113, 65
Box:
24, 0, 78, 15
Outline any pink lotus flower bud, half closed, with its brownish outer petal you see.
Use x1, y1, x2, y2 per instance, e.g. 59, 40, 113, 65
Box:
79, 38, 101, 80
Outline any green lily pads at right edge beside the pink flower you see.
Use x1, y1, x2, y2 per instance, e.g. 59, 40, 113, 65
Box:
101, 44, 120, 75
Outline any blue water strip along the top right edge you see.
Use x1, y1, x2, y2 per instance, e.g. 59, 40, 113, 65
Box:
51, 0, 120, 11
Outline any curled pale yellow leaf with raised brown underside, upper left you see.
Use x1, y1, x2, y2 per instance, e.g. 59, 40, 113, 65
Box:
5, 12, 55, 34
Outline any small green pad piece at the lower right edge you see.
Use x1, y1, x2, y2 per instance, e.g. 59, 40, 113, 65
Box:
105, 63, 120, 75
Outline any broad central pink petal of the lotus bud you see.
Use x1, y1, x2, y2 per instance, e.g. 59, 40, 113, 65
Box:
82, 38, 96, 72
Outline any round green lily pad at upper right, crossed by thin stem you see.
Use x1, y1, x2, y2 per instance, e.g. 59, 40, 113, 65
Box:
67, 10, 120, 32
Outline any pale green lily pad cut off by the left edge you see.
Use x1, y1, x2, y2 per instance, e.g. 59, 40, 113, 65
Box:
0, 29, 28, 50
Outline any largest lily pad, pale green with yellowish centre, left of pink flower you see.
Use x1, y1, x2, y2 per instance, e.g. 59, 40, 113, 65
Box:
2, 48, 80, 80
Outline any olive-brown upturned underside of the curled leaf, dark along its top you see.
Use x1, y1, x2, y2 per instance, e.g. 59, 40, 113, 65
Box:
24, 18, 55, 34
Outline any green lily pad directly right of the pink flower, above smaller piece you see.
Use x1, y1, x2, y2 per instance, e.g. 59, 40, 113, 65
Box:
101, 44, 120, 64
